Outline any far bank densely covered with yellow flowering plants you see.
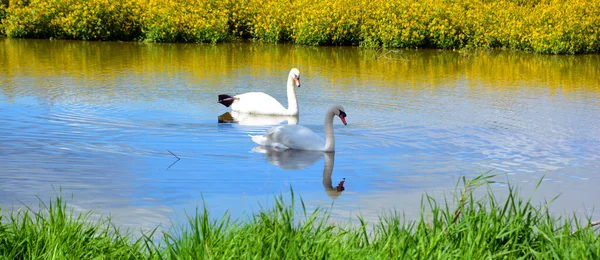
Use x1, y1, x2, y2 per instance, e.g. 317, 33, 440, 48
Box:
0, 0, 600, 54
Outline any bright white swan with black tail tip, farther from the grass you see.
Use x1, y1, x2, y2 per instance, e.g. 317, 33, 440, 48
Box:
218, 68, 300, 116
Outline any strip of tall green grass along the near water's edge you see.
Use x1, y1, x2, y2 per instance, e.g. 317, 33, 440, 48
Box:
0, 174, 600, 259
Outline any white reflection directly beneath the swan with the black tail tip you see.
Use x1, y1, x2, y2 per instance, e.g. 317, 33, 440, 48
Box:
219, 111, 299, 126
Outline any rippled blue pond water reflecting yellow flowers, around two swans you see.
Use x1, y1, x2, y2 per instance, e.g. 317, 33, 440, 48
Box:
0, 39, 600, 232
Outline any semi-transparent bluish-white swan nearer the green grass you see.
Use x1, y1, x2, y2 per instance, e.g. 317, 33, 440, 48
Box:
250, 105, 346, 152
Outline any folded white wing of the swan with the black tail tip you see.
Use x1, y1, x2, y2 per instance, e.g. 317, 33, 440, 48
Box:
231, 92, 288, 115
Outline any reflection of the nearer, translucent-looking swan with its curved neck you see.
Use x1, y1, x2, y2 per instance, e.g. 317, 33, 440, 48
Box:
252, 146, 346, 199
